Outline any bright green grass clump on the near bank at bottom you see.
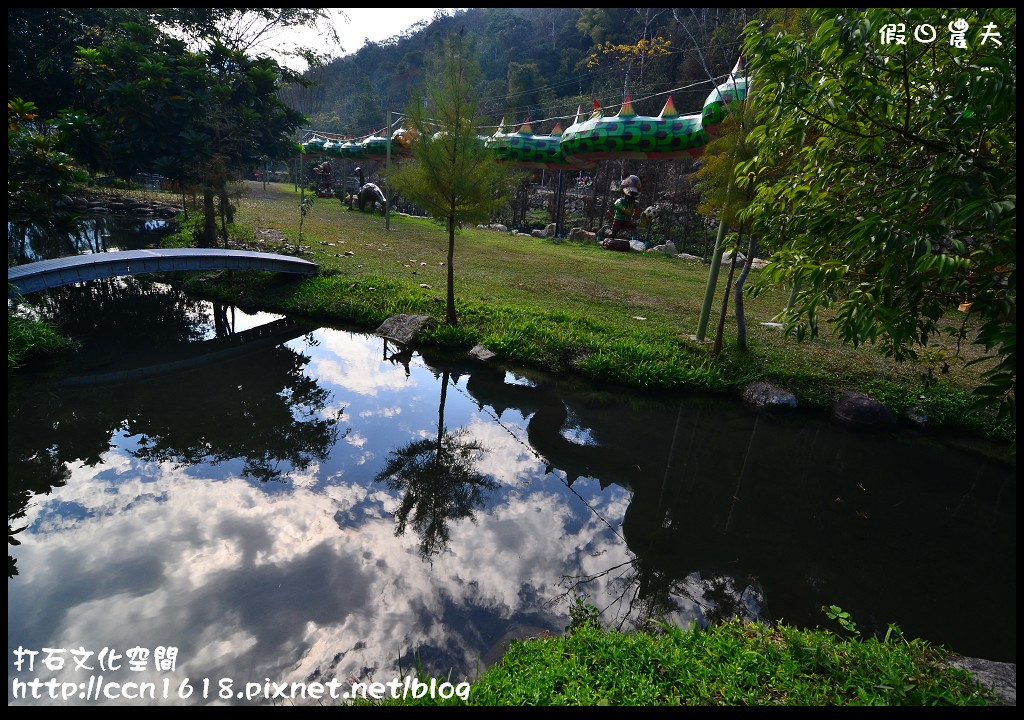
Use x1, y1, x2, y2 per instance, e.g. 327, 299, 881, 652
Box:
358, 621, 994, 706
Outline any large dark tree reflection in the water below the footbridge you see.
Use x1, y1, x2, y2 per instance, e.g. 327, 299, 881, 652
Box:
7, 279, 348, 576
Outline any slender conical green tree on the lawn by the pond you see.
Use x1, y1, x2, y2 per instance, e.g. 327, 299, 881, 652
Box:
389, 34, 511, 326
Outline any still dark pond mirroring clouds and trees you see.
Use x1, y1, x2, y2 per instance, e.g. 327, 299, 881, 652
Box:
8, 279, 1016, 703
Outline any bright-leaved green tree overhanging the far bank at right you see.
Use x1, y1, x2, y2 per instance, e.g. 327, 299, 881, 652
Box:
745, 8, 1017, 413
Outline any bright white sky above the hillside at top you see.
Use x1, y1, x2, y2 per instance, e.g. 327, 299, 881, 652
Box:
267, 7, 455, 71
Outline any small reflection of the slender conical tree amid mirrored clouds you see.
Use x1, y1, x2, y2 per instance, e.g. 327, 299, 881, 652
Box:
375, 371, 498, 560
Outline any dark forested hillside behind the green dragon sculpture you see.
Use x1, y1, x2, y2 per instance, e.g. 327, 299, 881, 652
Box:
286, 7, 755, 135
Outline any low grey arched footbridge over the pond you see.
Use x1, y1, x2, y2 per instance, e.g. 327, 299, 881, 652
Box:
7, 248, 319, 297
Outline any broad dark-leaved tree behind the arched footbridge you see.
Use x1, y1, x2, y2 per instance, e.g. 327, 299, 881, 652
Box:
74, 23, 303, 245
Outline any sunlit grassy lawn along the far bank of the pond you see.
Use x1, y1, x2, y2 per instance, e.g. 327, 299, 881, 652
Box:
167, 182, 1015, 438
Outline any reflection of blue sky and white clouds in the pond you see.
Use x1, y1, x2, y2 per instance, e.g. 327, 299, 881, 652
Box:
8, 330, 628, 708
